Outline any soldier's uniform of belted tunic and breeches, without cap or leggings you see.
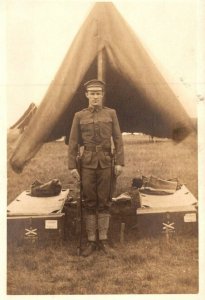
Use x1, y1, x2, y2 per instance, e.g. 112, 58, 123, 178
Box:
68, 107, 124, 213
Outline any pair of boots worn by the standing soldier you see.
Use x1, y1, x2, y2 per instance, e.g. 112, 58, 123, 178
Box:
81, 240, 116, 257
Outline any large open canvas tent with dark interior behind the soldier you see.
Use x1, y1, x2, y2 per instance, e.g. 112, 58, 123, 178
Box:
10, 2, 194, 172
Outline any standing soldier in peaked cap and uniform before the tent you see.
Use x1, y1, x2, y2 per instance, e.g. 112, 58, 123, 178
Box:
69, 79, 124, 256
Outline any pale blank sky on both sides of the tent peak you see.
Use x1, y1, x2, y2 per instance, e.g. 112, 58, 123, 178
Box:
5, 0, 200, 126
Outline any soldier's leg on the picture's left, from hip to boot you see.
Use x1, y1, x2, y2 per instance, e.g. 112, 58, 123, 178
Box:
82, 168, 97, 256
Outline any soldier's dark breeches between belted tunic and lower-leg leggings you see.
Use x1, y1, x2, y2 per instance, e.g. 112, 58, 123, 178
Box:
82, 167, 111, 214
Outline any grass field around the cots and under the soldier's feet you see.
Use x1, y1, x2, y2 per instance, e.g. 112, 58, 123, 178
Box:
7, 135, 198, 295
